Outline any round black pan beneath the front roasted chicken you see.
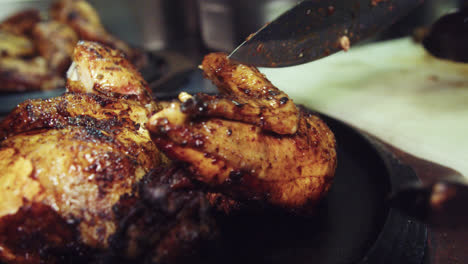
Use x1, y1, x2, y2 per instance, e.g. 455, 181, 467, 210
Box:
154, 70, 427, 264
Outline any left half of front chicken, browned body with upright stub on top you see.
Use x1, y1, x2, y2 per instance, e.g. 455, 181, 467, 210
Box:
0, 42, 163, 263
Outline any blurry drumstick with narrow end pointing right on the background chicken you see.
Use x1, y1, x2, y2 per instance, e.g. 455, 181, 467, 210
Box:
50, 0, 136, 60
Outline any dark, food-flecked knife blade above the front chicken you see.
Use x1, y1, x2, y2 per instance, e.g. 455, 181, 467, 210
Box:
230, 0, 423, 67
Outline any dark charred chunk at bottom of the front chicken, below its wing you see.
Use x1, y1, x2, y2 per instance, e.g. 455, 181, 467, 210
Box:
108, 164, 219, 263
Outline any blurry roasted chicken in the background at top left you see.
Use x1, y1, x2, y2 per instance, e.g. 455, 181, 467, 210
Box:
0, 0, 145, 92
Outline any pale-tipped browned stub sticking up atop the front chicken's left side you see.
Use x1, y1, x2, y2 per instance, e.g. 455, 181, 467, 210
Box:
67, 41, 153, 104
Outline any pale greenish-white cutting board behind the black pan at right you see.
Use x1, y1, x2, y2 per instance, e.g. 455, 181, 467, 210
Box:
261, 38, 468, 177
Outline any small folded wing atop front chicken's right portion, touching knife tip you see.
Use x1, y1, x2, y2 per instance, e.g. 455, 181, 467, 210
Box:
182, 53, 299, 134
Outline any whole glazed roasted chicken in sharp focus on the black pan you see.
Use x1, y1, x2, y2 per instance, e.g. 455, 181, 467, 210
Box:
0, 42, 336, 263
